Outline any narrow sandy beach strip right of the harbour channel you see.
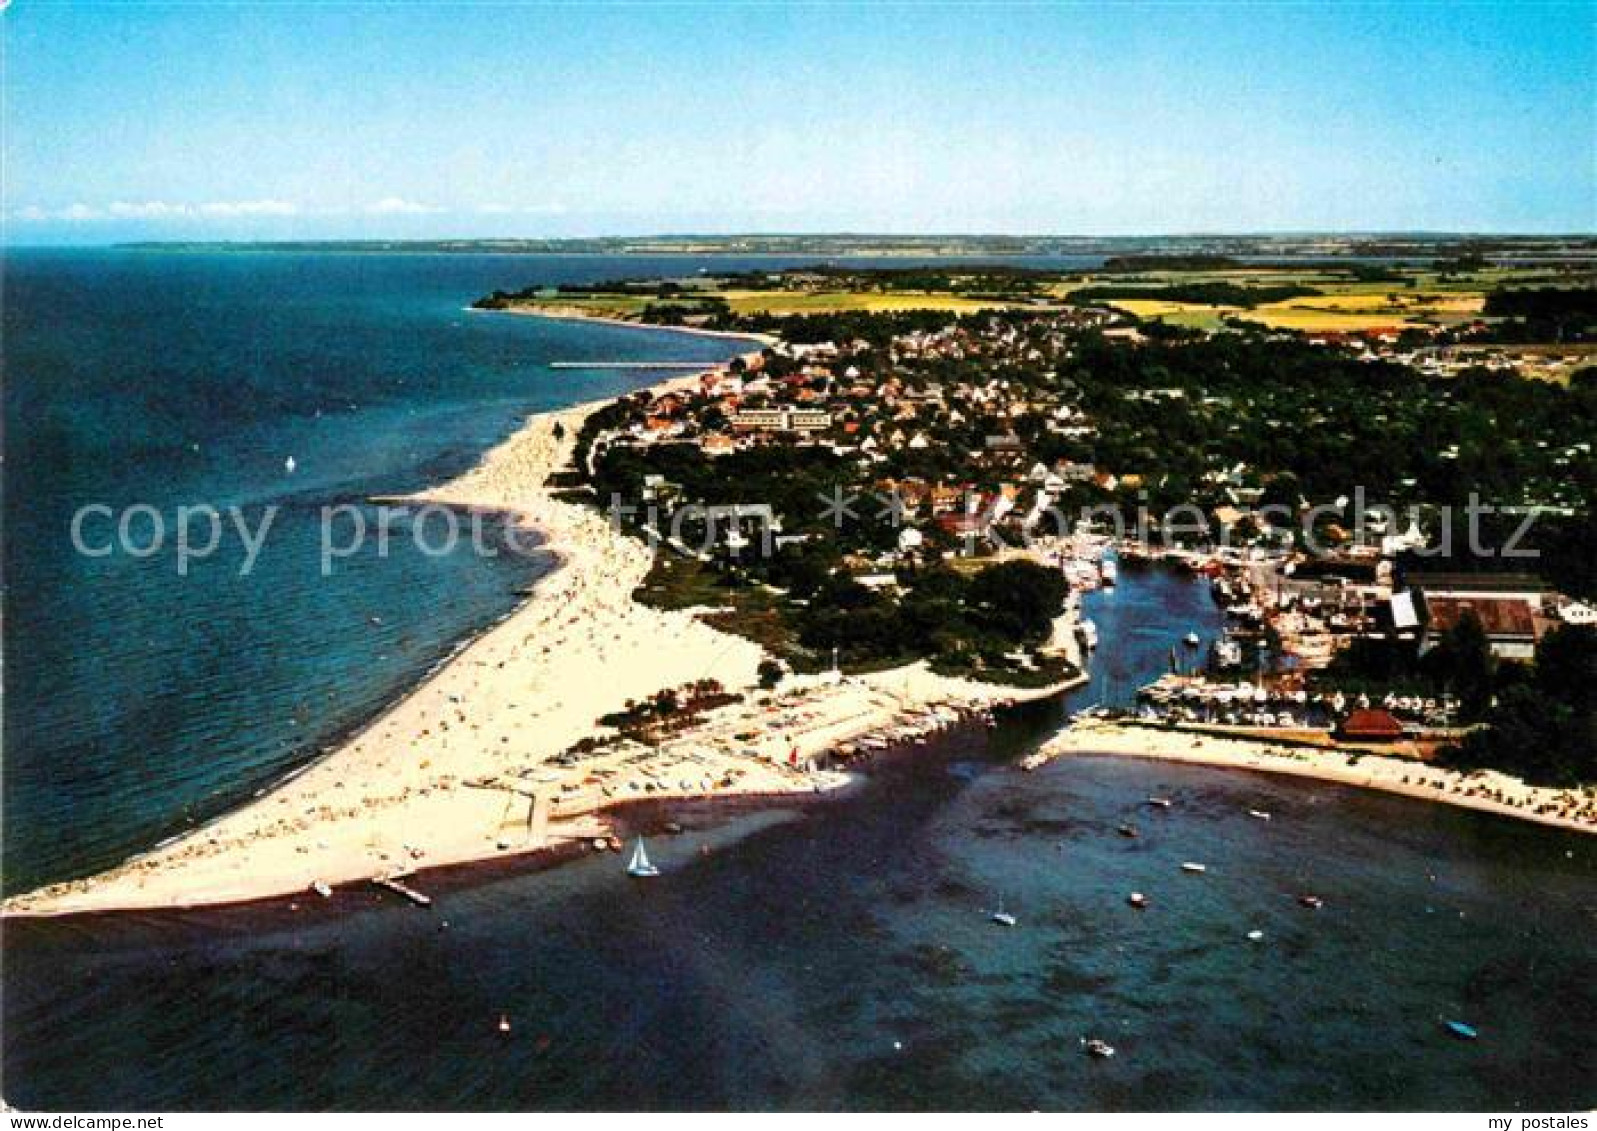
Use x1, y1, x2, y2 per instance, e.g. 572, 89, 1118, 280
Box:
1041, 717, 1597, 832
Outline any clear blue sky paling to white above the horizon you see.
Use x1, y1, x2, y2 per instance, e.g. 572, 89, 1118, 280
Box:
0, 0, 1597, 243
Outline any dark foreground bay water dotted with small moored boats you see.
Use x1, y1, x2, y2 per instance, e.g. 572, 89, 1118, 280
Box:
5, 719, 1597, 1110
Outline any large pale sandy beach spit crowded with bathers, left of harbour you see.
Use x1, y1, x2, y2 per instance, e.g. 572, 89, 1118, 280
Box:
3, 367, 1048, 914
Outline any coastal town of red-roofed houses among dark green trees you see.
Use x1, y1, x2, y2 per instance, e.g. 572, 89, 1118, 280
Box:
501, 258, 1597, 823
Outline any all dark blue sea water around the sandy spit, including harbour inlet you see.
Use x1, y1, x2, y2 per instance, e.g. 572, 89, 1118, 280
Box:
0, 251, 1597, 1110
